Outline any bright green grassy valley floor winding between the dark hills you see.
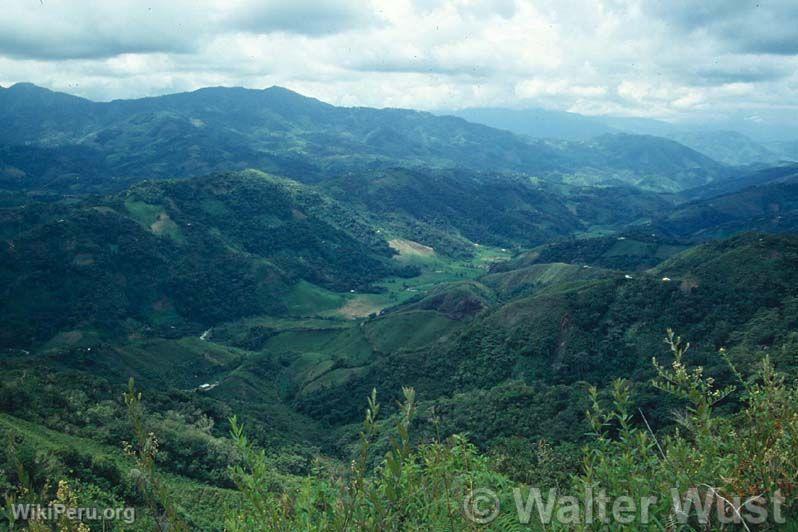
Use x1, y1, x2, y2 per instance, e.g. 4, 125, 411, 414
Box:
174, 246, 510, 408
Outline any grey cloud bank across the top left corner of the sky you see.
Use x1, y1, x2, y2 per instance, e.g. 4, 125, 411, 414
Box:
0, 0, 379, 60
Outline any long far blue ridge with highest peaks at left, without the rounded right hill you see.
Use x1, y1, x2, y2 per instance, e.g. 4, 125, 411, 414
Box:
0, 84, 560, 185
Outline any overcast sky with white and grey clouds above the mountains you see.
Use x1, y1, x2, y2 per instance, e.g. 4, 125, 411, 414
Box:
0, 0, 798, 122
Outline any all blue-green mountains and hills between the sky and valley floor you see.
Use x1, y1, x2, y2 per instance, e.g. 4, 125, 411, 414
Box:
0, 84, 798, 346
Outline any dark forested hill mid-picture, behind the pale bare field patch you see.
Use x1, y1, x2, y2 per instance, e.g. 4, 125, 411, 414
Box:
324, 169, 583, 254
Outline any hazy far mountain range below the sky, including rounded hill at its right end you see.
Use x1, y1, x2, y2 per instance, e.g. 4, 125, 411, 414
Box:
0, 84, 725, 192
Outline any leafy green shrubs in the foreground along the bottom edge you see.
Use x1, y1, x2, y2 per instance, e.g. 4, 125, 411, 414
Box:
3, 332, 798, 531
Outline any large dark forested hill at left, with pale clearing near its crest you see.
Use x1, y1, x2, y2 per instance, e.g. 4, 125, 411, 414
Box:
0, 172, 416, 347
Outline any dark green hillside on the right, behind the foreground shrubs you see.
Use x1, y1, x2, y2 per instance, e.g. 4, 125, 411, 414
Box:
290, 234, 796, 434
